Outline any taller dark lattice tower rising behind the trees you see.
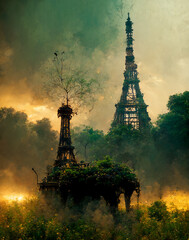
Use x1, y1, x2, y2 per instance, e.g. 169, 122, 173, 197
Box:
113, 13, 150, 130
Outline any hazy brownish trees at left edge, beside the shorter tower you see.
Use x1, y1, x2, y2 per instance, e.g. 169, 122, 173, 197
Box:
0, 108, 58, 178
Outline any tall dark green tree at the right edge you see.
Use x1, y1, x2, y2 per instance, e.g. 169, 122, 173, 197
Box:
154, 91, 189, 153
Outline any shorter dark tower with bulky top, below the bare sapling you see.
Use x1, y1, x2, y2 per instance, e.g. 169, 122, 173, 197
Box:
54, 101, 77, 167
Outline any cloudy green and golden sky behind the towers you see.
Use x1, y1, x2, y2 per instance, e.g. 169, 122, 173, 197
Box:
0, 0, 189, 131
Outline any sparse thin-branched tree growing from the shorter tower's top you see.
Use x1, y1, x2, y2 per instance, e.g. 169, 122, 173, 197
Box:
44, 51, 99, 107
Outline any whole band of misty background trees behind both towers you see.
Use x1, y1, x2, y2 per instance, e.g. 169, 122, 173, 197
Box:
0, 91, 189, 192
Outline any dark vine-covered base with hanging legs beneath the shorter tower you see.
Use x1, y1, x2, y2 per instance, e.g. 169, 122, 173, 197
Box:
48, 156, 140, 211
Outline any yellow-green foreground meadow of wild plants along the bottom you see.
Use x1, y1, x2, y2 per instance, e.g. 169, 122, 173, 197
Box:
0, 199, 189, 240
